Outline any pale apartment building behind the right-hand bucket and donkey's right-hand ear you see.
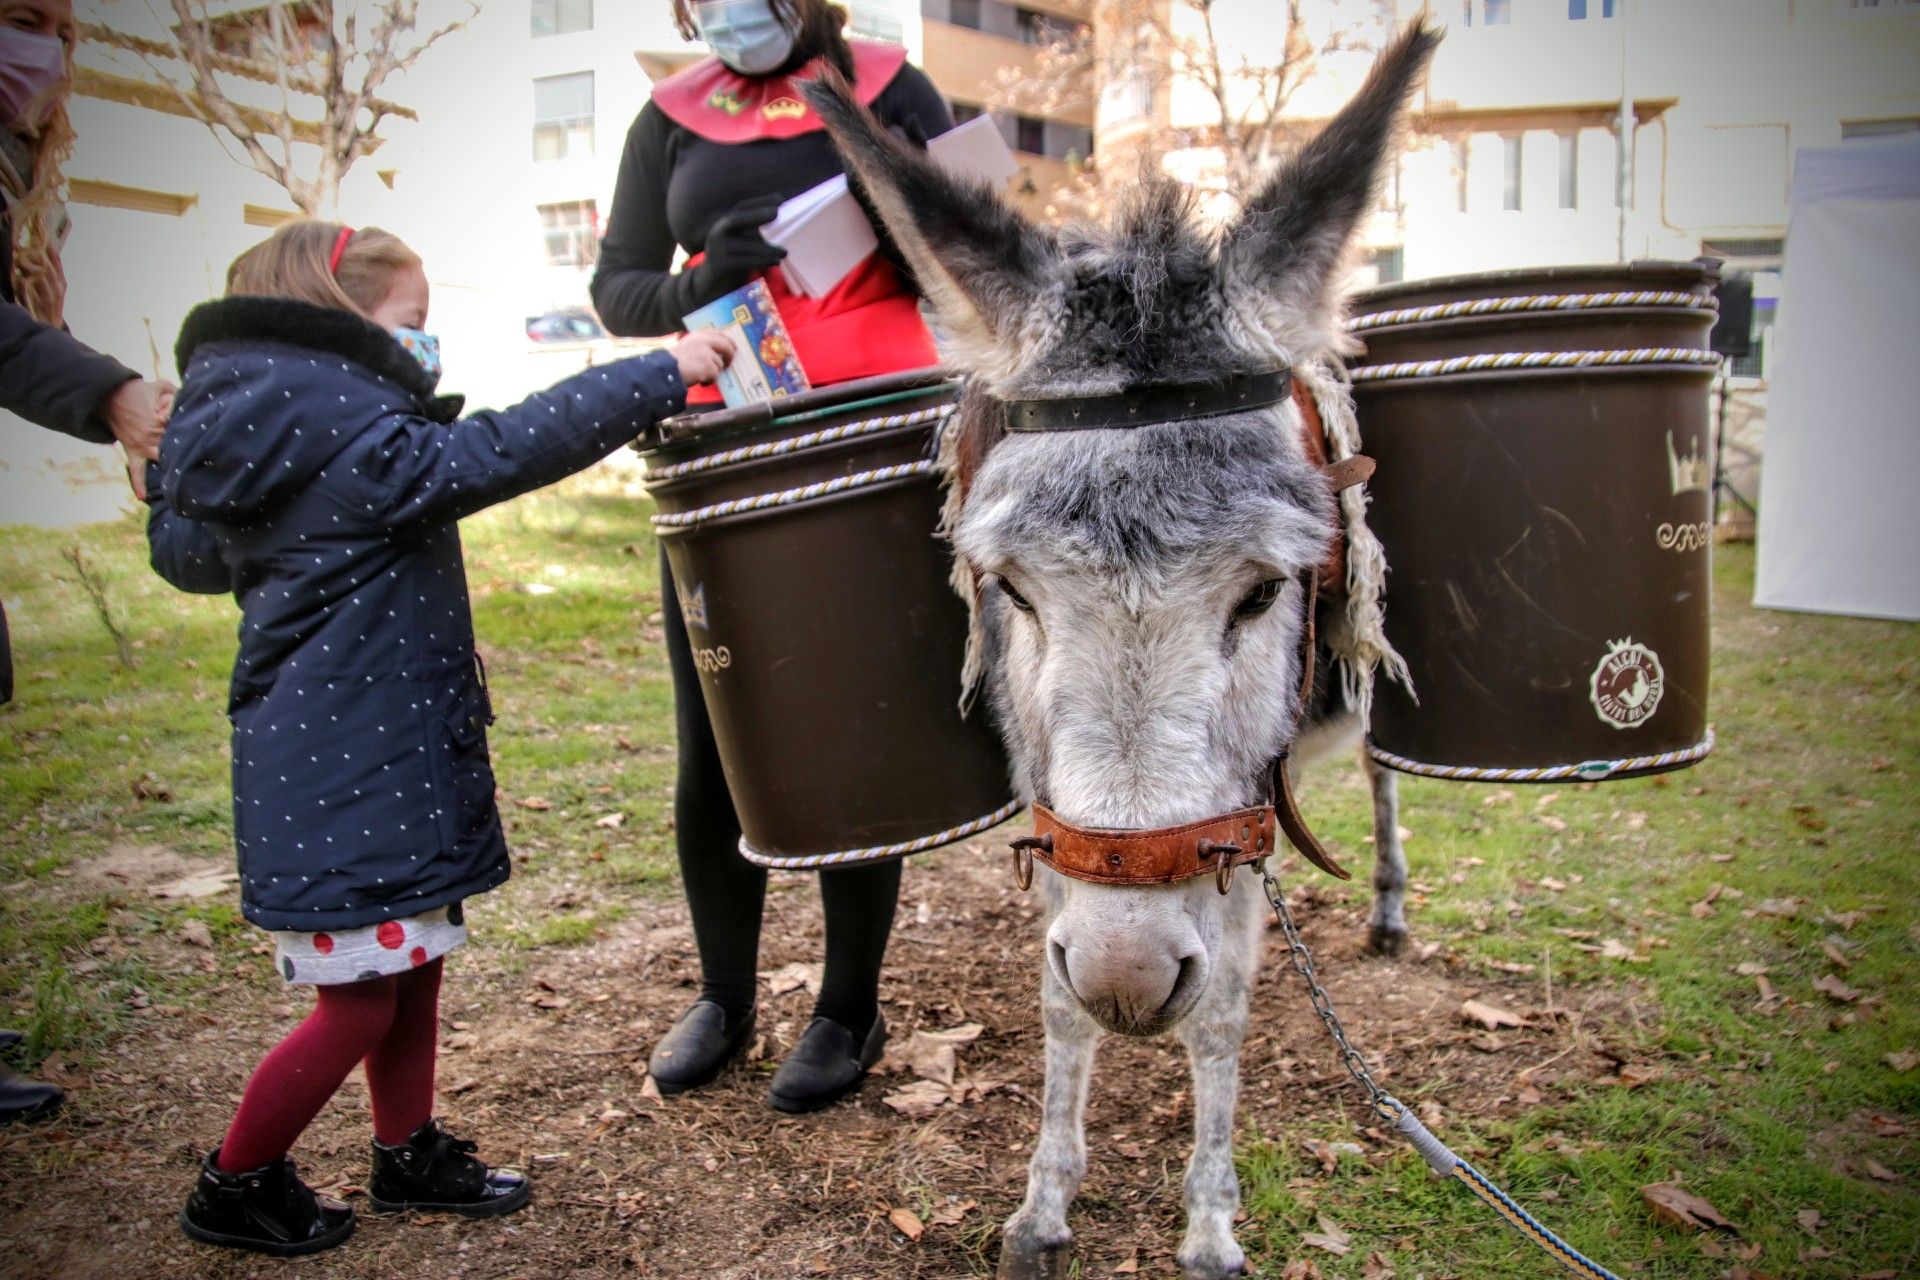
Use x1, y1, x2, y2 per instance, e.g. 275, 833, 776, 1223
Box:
1096, 0, 1920, 374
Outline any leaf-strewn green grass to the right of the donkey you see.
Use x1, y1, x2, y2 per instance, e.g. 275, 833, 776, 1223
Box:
1242, 547, 1920, 1276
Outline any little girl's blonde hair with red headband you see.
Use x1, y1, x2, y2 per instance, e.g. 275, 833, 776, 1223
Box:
227, 219, 420, 315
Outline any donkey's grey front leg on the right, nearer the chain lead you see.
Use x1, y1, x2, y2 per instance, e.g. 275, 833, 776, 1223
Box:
1175, 905, 1258, 1280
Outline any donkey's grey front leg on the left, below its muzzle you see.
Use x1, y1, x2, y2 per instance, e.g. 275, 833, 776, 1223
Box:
1000, 967, 1100, 1280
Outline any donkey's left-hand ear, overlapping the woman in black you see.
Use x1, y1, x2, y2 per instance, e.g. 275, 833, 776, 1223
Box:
801, 71, 1060, 358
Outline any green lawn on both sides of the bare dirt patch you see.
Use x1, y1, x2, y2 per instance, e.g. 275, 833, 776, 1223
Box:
0, 486, 1920, 1278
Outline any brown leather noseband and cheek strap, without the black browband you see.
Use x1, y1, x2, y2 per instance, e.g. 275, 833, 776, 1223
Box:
1012, 455, 1373, 892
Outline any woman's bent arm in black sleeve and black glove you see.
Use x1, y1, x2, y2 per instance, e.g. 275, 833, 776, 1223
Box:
591, 102, 787, 338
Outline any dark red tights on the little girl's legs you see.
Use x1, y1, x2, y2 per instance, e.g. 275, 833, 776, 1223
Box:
217, 960, 440, 1173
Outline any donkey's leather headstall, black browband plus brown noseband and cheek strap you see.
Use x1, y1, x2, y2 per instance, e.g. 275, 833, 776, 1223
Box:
1006, 370, 1373, 894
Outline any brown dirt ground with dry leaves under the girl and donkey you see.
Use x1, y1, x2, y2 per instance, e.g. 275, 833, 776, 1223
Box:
0, 842, 1630, 1280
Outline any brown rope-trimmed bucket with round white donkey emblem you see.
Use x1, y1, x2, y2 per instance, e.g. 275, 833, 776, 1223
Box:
1352, 263, 1718, 783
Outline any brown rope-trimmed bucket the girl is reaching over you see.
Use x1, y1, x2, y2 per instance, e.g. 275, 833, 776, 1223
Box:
637, 368, 1020, 867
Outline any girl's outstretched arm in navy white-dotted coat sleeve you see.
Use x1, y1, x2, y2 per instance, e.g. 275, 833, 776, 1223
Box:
348, 351, 687, 528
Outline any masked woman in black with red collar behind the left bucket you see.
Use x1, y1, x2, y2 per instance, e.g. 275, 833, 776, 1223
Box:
593, 0, 952, 1111
